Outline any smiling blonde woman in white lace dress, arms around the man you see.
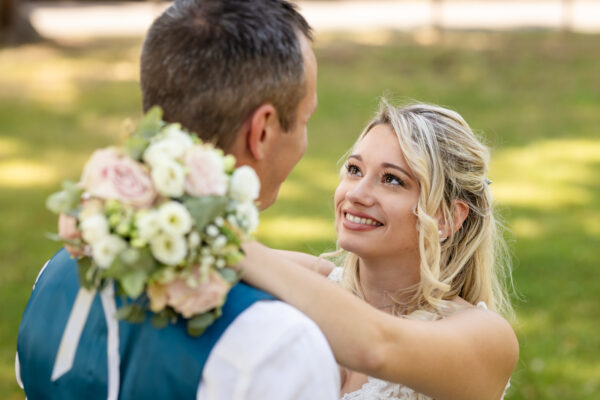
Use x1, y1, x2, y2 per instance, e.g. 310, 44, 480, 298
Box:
241, 102, 518, 400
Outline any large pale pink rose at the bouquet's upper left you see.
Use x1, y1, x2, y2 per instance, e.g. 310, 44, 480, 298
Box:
80, 148, 156, 207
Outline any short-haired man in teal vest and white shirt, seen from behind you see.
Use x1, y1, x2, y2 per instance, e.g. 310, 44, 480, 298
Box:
17, 0, 339, 400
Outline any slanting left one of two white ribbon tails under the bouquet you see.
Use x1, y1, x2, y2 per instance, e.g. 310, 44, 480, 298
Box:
50, 288, 96, 382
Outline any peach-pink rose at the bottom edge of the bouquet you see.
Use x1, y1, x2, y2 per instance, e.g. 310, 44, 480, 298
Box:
148, 267, 230, 318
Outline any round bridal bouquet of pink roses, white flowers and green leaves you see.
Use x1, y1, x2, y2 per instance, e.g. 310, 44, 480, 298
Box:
47, 108, 259, 336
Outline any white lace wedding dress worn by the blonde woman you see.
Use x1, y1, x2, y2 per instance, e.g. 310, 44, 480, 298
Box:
329, 267, 510, 400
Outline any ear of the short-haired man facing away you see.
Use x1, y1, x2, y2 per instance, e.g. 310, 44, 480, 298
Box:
246, 103, 281, 160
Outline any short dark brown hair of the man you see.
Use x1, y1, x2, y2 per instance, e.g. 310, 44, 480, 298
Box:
141, 0, 311, 149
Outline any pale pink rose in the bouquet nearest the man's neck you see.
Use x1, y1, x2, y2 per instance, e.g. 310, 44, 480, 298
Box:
185, 145, 227, 196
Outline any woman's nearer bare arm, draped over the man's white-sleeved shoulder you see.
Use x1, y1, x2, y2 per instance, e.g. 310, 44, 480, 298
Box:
241, 243, 518, 400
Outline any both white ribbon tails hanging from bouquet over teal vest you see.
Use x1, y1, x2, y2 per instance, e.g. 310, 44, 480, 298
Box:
50, 281, 120, 400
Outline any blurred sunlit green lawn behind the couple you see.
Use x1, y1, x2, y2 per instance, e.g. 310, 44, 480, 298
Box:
0, 32, 600, 399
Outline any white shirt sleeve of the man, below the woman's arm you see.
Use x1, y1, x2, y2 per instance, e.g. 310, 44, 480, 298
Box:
198, 301, 340, 400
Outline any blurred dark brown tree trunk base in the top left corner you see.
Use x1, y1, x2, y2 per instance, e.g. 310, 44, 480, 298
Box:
0, 0, 42, 45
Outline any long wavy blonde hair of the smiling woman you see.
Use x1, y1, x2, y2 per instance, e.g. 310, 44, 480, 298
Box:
342, 100, 512, 320
